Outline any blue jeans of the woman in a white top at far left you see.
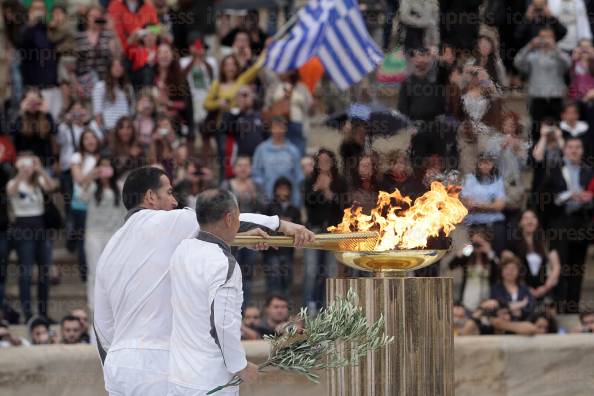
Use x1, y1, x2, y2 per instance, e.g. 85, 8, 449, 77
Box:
12, 216, 52, 322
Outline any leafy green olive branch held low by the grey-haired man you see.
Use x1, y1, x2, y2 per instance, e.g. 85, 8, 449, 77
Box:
207, 289, 394, 395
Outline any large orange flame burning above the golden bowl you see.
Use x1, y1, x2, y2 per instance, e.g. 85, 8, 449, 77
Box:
328, 181, 468, 251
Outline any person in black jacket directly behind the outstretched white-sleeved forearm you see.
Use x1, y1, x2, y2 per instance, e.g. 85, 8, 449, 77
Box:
263, 177, 301, 298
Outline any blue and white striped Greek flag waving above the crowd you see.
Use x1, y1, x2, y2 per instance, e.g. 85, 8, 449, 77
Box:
264, 0, 384, 89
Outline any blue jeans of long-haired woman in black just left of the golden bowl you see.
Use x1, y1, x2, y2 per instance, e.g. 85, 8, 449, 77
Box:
303, 249, 338, 309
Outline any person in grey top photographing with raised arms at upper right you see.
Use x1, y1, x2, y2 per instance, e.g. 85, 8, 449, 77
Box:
514, 26, 571, 141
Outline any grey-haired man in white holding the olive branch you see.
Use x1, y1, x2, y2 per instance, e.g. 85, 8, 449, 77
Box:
168, 189, 258, 396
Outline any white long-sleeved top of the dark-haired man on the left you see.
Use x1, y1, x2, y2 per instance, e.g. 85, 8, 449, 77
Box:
94, 208, 279, 354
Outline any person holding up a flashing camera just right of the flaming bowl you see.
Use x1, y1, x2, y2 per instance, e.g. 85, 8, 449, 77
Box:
450, 229, 498, 311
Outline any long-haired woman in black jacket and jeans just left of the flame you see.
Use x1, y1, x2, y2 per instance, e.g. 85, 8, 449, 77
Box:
303, 148, 347, 312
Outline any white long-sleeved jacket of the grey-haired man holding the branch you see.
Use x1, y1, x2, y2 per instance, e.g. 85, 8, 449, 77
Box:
169, 232, 247, 391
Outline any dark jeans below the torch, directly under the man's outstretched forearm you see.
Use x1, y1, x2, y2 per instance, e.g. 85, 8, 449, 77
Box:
264, 252, 293, 299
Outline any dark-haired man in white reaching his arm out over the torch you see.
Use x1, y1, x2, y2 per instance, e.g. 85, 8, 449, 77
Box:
94, 167, 313, 396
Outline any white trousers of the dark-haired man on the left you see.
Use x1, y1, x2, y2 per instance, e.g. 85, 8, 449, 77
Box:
103, 349, 169, 396
